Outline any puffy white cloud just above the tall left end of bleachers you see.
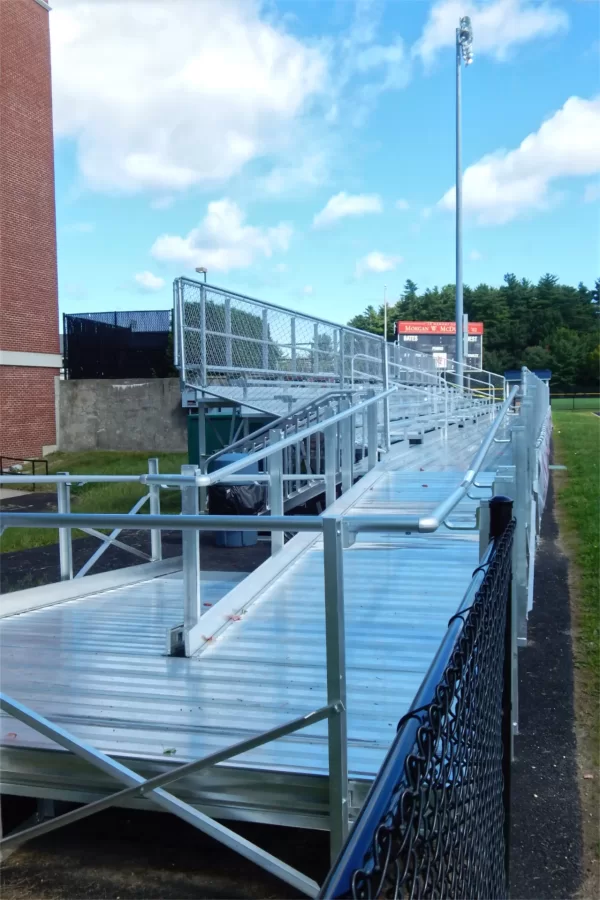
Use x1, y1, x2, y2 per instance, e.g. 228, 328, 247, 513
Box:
151, 198, 292, 272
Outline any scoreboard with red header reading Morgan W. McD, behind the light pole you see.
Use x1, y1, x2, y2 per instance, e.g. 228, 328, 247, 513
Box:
396, 322, 483, 372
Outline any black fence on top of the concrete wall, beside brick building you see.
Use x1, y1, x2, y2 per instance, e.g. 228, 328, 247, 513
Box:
63, 309, 177, 378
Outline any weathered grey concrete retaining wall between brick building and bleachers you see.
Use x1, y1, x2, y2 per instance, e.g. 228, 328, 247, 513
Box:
56, 378, 187, 452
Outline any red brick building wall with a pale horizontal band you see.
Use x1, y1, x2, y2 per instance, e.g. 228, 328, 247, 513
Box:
0, 0, 60, 456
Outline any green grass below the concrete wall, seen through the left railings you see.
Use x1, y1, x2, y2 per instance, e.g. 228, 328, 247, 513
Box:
0, 450, 187, 553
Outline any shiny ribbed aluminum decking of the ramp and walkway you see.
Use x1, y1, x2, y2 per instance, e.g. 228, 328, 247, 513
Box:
0, 417, 516, 805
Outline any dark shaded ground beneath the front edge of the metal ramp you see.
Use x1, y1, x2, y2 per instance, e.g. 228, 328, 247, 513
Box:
0, 798, 328, 900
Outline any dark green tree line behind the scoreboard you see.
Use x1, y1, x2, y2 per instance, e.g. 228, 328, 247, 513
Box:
348, 274, 600, 391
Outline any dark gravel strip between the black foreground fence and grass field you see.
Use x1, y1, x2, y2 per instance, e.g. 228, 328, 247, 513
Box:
510, 474, 582, 900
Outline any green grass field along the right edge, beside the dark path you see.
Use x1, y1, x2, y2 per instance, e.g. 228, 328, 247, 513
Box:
553, 411, 600, 765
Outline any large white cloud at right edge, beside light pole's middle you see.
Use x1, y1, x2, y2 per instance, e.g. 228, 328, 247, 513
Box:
438, 97, 600, 224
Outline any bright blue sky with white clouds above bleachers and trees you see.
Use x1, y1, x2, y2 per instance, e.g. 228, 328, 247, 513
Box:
50, 0, 600, 321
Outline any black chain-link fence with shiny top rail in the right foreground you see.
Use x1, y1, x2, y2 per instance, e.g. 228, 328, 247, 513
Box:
321, 506, 514, 900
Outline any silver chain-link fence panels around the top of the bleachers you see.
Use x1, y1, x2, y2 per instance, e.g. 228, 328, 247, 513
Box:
175, 278, 435, 415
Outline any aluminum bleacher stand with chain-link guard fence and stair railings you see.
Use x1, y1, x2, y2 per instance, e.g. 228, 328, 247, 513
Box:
174, 278, 504, 511
